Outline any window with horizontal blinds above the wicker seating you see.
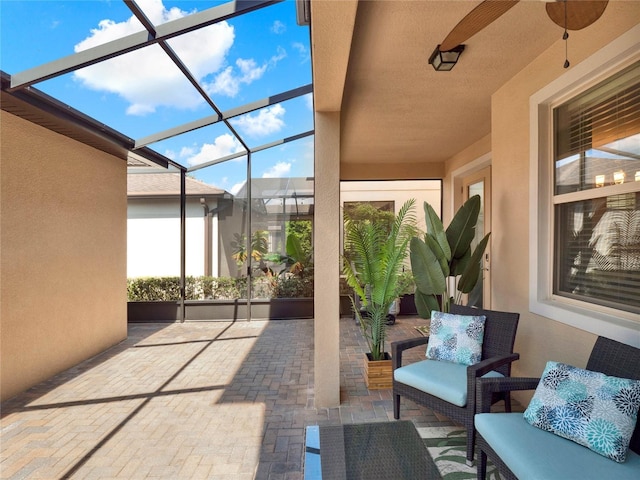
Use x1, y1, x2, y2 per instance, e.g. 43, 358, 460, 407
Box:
553, 63, 640, 313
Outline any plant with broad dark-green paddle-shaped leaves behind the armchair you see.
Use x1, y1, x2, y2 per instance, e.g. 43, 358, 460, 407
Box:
410, 195, 491, 318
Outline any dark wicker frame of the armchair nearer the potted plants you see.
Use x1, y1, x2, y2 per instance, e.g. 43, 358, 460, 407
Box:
391, 305, 520, 464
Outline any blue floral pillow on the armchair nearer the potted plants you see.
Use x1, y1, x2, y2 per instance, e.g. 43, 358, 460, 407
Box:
427, 311, 486, 365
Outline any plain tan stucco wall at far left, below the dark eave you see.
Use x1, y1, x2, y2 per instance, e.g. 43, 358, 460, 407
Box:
0, 111, 127, 400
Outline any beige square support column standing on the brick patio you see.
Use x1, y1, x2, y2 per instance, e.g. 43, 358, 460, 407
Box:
313, 112, 342, 408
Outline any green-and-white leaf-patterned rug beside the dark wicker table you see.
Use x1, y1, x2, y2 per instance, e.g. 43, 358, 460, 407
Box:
417, 427, 502, 480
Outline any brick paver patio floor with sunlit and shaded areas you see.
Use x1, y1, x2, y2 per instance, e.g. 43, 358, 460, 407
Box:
0, 317, 460, 480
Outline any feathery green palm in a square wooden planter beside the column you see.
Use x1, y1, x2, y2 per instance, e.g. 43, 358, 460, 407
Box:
343, 199, 416, 388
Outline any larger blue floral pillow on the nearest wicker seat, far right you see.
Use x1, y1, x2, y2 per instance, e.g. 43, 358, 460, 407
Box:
524, 362, 640, 462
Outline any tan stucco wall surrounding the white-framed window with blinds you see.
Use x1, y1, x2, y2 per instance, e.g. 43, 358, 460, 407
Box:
484, 6, 640, 394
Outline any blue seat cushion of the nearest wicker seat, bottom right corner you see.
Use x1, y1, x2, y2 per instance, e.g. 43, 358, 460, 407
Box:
475, 413, 640, 480
